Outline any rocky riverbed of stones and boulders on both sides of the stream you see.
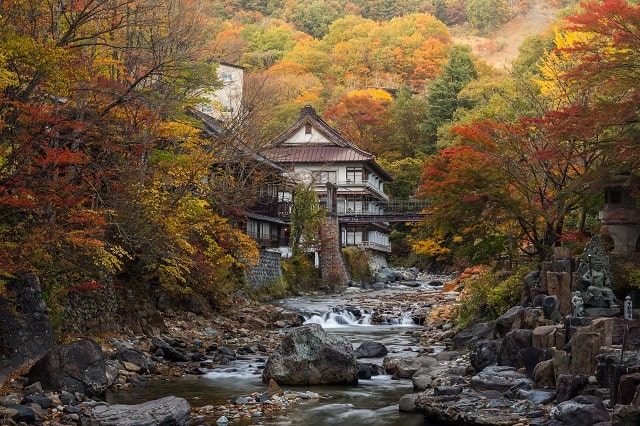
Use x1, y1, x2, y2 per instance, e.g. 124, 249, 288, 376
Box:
0, 271, 640, 426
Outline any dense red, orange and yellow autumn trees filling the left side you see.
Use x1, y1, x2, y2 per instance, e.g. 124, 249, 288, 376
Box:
0, 1, 256, 308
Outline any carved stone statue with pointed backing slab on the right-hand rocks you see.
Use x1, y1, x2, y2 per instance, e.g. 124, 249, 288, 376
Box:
576, 235, 620, 317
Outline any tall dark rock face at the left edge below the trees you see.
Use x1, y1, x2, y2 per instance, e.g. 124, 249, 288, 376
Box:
0, 274, 55, 383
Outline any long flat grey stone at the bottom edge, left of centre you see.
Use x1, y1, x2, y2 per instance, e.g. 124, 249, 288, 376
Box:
90, 396, 191, 426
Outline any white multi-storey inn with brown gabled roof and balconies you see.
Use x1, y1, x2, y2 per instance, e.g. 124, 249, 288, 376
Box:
267, 106, 392, 252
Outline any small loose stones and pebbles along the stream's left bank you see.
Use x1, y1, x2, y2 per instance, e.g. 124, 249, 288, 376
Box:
1, 282, 460, 425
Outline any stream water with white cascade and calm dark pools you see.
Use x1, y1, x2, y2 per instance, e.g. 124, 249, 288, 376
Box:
107, 286, 448, 426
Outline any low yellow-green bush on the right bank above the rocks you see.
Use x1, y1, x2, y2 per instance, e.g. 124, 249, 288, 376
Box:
457, 266, 531, 329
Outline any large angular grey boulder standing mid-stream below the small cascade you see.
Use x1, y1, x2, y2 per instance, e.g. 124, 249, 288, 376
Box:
262, 324, 358, 385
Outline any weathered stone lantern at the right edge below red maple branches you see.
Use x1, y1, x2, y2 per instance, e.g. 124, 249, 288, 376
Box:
599, 175, 640, 254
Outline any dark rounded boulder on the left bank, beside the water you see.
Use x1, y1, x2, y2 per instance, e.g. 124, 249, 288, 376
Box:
29, 339, 107, 397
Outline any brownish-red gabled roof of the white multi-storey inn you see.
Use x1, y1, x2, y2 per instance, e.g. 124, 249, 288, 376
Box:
267, 105, 393, 181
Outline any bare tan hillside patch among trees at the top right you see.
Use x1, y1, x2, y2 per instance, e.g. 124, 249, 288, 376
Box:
451, 0, 561, 69
